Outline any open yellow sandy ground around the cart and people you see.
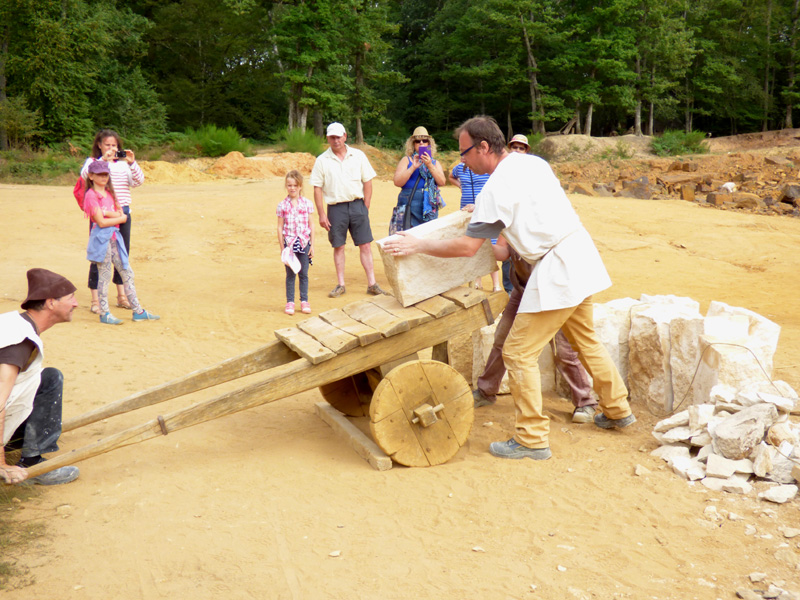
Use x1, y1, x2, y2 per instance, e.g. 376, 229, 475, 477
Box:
0, 178, 800, 600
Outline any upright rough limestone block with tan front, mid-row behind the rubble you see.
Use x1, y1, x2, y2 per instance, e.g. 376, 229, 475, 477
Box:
628, 304, 702, 412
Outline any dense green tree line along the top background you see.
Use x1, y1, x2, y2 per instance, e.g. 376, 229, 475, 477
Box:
0, 0, 800, 149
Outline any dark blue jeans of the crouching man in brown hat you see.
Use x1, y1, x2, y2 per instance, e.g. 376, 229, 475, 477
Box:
6, 367, 64, 458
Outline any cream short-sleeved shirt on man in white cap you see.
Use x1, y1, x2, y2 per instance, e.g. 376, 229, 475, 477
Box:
311, 146, 376, 205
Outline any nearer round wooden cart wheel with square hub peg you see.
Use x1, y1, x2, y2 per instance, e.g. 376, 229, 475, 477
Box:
369, 360, 474, 467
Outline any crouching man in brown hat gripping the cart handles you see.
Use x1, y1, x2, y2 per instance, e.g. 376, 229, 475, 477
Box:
0, 269, 78, 485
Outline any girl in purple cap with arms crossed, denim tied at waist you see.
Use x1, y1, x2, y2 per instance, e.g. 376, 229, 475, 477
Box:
83, 160, 159, 325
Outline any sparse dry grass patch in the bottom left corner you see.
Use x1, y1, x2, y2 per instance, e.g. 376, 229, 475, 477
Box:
0, 484, 45, 590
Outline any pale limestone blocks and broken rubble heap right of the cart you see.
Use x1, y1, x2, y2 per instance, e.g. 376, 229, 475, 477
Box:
473, 295, 800, 502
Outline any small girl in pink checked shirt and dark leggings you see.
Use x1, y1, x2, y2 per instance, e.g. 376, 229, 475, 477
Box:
277, 170, 314, 315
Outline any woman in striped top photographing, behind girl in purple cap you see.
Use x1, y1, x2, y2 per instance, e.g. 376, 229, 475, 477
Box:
81, 129, 144, 314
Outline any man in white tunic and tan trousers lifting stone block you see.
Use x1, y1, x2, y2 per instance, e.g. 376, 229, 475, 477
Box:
384, 116, 636, 460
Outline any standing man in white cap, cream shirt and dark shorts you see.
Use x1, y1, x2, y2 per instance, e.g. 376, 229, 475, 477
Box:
311, 123, 385, 298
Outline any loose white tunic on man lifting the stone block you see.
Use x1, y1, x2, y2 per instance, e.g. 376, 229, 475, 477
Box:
472, 153, 611, 313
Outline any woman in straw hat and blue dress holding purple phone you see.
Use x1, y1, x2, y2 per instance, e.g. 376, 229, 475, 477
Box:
389, 127, 446, 234
